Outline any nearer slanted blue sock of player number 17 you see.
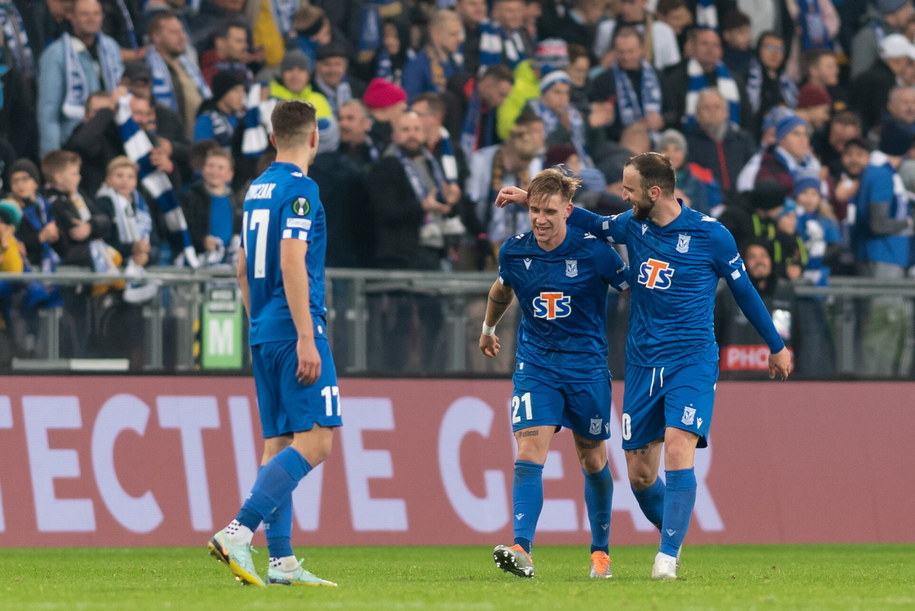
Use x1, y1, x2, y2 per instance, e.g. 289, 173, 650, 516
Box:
235, 446, 311, 536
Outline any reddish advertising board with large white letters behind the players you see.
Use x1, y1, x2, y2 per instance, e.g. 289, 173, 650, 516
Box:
0, 377, 915, 547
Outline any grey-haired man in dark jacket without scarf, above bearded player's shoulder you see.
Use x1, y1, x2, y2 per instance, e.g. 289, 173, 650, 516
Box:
686, 87, 756, 194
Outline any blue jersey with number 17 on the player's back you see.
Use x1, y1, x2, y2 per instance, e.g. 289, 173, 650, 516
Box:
241, 163, 327, 345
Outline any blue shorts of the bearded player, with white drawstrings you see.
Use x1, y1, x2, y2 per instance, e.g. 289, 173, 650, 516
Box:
622, 361, 718, 450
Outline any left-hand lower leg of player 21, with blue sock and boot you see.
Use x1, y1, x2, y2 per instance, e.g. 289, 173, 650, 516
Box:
492, 426, 556, 577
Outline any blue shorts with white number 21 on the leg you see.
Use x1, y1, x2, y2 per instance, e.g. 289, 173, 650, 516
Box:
511, 363, 610, 439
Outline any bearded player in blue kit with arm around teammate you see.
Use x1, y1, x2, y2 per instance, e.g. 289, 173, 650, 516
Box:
496, 153, 792, 579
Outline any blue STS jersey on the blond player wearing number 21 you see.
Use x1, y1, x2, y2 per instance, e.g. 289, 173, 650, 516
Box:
499, 227, 629, 382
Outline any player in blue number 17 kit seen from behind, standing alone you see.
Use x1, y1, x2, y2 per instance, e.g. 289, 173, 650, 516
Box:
207, 101, 342, 586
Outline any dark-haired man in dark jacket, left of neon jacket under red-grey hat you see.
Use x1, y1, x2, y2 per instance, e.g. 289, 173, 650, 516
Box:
444, 64, 514, 155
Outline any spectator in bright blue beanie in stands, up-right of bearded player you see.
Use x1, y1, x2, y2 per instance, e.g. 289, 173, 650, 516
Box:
737, 113, 820, 193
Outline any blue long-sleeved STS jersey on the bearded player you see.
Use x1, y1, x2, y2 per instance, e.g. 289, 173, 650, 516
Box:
569, 202, 746, 367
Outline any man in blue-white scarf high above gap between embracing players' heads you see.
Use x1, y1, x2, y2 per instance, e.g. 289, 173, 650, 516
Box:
592, 26, 664, 140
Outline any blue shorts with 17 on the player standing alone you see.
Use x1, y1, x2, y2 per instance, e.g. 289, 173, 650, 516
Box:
251, 336, 343, 438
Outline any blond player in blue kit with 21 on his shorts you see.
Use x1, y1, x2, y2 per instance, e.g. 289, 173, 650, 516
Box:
480, 169, 629, 578
